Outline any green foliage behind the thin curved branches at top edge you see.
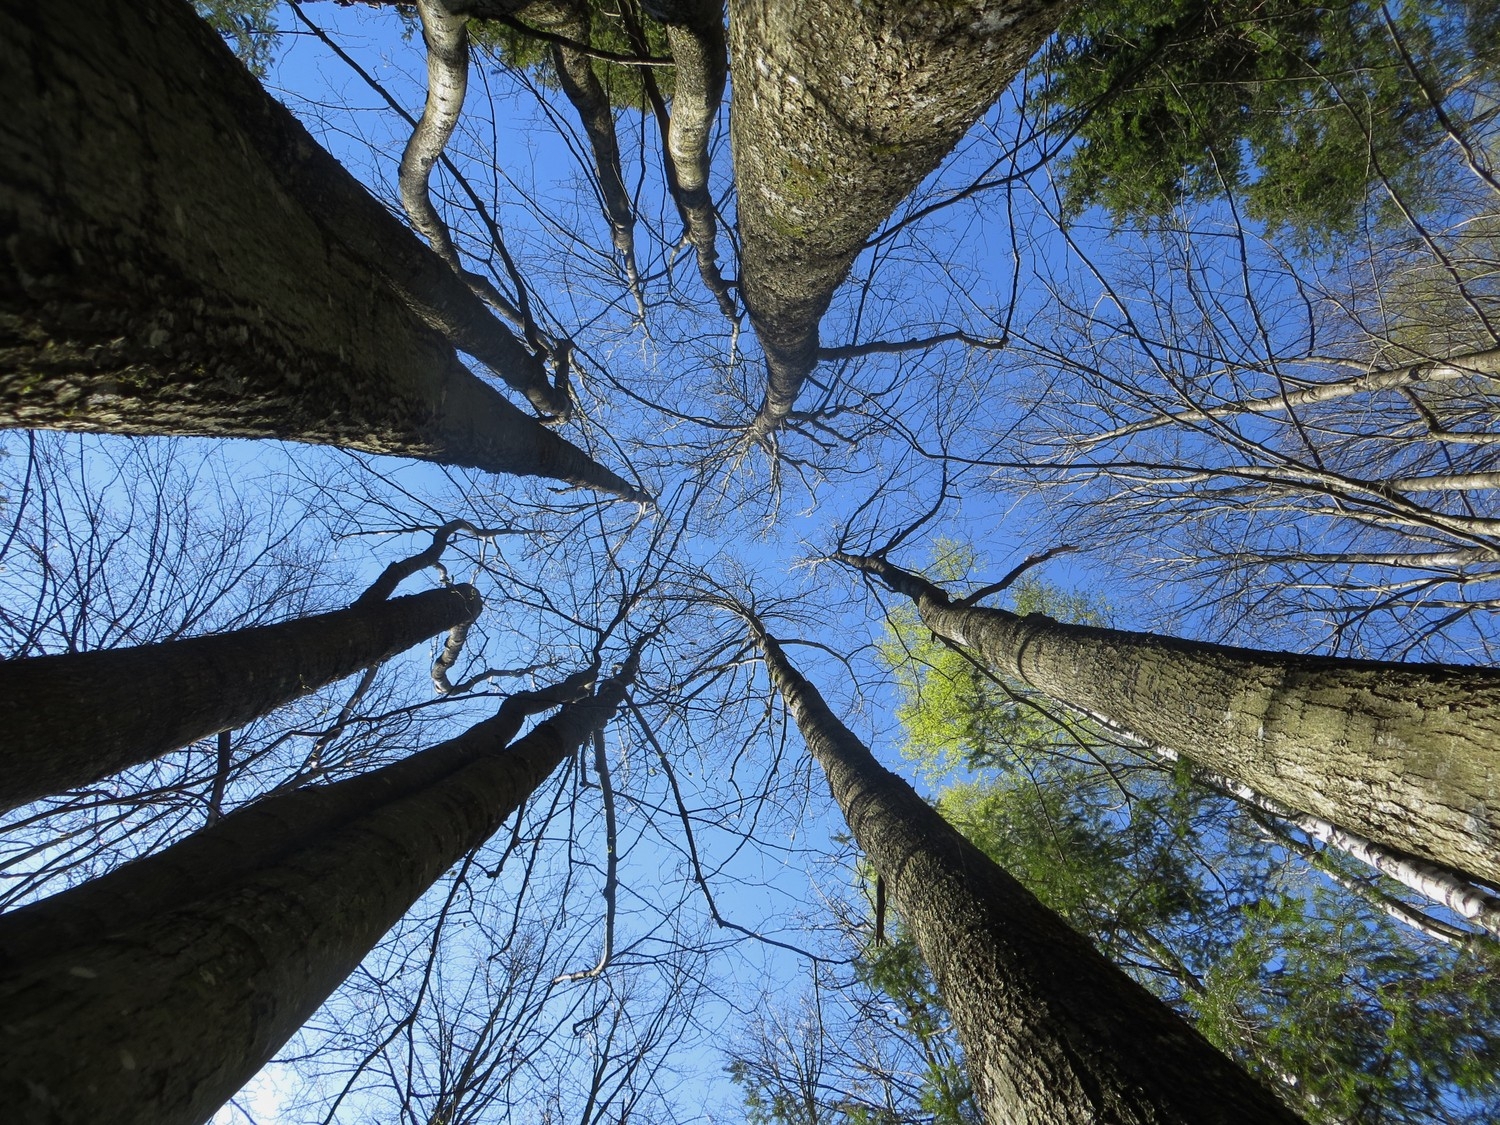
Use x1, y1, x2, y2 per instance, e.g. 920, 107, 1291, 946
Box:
470, 0, 672, 110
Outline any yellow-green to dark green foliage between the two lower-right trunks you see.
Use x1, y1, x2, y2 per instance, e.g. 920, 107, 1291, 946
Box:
863, 543, 1500, 1125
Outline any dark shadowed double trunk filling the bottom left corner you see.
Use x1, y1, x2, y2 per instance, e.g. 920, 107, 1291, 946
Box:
0, 657, 636, 1125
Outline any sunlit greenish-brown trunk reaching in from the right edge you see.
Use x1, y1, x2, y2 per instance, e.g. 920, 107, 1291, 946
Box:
837, 555, 1500, 885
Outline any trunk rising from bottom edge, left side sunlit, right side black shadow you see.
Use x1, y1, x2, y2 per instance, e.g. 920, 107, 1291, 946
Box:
750, 620, 1298, 1125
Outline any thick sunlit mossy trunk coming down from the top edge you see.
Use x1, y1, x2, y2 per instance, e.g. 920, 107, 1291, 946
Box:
729, 0, 1073, 440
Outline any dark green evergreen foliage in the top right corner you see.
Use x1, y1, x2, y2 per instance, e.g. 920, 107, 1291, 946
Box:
1032, 0, 1497, 240
